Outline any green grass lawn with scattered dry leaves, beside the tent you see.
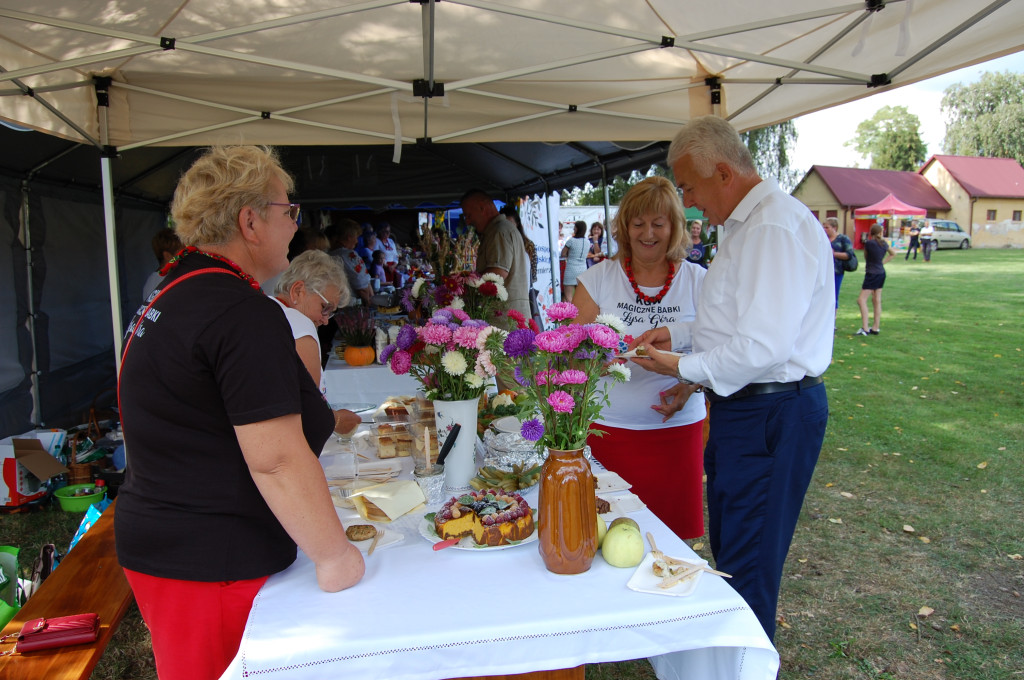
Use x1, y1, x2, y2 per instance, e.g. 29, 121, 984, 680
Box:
0, 250, 1024, 680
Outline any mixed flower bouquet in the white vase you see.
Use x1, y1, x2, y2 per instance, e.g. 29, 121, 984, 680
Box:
381, 308, 497, 401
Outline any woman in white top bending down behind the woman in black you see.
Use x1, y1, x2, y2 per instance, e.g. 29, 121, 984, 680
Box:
271, 250, 360, 432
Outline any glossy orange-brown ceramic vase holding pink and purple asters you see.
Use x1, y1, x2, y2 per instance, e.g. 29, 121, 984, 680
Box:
537, 449, 597, 573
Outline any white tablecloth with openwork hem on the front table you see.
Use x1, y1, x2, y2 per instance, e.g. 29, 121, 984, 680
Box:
216, 456, 778, 680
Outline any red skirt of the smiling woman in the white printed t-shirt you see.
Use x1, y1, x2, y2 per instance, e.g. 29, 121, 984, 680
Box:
587, 421, 705, 539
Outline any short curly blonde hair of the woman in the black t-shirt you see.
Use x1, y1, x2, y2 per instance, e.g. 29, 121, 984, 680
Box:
171, 145, 295, 246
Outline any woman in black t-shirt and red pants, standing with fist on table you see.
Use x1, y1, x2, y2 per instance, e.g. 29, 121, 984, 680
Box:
114, 146, 365, 680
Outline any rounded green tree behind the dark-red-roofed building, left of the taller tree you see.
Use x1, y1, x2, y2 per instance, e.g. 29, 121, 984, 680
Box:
846, 107, 928, 171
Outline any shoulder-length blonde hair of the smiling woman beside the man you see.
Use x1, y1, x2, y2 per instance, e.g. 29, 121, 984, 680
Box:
611, 176, 691, 262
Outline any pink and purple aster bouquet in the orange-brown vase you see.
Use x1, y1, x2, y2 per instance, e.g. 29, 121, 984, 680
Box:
487, 302, 630, 451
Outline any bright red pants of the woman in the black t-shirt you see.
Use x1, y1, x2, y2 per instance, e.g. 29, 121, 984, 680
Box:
125, 569, 267, 680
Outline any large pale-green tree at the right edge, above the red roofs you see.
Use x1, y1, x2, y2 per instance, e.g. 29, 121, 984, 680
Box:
942, 73, 1024, 163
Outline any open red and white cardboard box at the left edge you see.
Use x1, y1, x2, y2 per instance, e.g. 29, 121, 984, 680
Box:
0, 430, 68, 507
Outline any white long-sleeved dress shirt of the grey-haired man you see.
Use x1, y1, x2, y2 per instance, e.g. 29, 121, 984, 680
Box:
667, 180, 836, 396
